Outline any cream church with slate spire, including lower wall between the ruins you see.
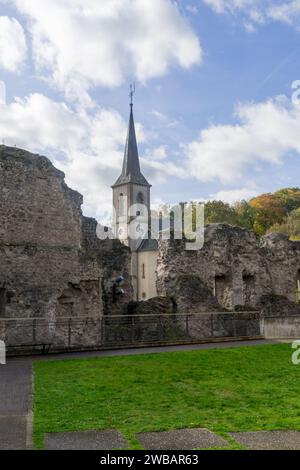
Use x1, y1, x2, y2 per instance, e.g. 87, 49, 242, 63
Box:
112, 87, 158, 300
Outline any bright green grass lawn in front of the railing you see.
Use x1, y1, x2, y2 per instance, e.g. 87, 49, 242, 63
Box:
34, 344, 300, 449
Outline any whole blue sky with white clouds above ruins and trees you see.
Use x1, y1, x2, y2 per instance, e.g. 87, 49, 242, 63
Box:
0, 0, 300, 218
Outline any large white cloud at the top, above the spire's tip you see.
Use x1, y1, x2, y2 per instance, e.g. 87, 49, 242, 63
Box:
11, 0, 202, 100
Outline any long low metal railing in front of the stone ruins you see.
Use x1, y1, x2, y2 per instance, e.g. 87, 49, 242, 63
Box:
0, 312, 260, 351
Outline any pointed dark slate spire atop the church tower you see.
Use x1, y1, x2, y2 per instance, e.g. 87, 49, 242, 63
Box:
112, 101, 151, 187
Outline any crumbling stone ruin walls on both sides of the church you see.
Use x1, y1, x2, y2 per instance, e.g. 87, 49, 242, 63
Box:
0, 146, 300, 349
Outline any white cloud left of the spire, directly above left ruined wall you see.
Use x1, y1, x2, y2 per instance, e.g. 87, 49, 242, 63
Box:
0, 94, 130, 216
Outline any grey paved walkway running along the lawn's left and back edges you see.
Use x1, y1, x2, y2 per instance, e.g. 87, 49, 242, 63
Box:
0, 340, 277, 450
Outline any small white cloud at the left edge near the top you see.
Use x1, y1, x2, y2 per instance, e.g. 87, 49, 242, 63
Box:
0, 16, 27, 72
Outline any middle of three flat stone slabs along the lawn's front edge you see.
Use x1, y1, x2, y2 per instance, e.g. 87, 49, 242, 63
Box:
137, 428, 228, 450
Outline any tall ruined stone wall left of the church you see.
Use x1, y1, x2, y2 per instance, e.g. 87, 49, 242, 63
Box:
0, 146, 132, 343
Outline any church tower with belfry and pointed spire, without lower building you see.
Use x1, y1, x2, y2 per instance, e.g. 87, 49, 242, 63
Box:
112, 88, 151, 252
